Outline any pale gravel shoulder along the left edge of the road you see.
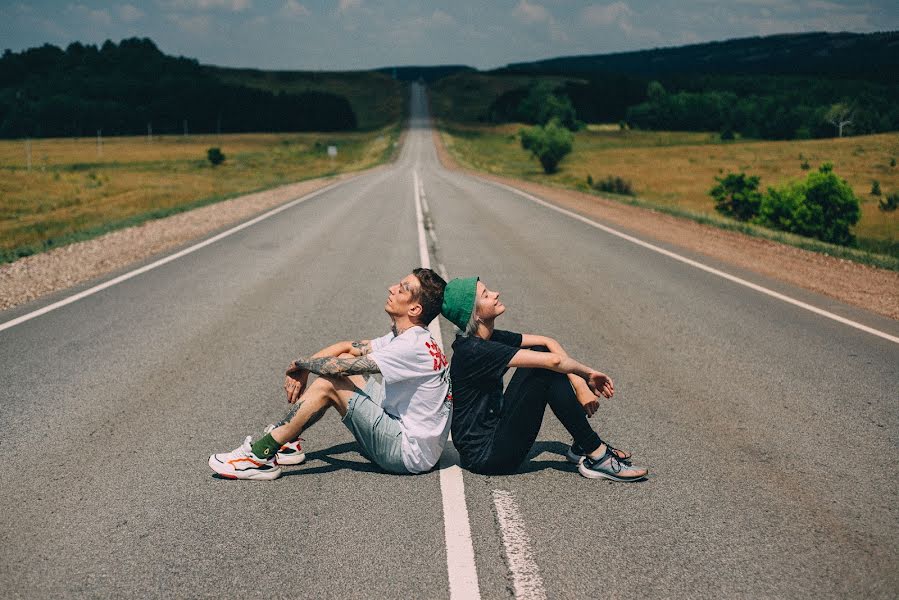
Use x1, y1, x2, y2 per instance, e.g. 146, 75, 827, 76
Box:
0, 167, 374, 310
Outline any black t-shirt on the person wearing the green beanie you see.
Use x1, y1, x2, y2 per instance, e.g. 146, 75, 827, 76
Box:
450, 329, 521, 468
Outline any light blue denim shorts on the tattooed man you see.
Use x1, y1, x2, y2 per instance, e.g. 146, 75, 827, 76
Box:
343, 377, 409, 474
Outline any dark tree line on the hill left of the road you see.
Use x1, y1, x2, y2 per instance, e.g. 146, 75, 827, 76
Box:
0, 38, 357, 138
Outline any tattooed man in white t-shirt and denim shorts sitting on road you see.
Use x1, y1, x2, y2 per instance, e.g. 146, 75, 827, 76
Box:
209, 269, 452, 480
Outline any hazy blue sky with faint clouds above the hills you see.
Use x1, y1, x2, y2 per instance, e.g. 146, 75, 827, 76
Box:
0, 0, 899, 70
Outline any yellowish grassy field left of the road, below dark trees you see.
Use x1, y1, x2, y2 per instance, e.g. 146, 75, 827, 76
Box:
0, 125, 401, 263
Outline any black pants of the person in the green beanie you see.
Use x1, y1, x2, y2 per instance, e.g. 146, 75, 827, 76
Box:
473, 346, 602, 473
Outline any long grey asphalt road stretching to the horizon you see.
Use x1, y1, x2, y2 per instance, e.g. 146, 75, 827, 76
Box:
0, 82, 899, 598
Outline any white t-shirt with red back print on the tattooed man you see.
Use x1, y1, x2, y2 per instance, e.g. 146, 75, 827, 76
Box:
369, 325, 452, 473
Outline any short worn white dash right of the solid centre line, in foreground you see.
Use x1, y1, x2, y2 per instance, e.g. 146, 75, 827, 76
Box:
493, 490, 546, 600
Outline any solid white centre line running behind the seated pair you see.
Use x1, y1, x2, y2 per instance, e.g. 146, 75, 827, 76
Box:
412, 170, 481, 600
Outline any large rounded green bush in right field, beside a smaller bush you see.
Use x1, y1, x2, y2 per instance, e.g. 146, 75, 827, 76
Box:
756, 163, 861, 245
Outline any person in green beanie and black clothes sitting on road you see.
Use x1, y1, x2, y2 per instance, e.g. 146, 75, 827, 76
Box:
441, 277, 647, 481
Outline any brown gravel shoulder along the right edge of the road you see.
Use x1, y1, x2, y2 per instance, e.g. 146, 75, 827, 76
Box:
434, 130, 899, 319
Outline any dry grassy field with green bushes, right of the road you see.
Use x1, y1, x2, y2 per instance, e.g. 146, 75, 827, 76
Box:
440, 123, 899, 271
